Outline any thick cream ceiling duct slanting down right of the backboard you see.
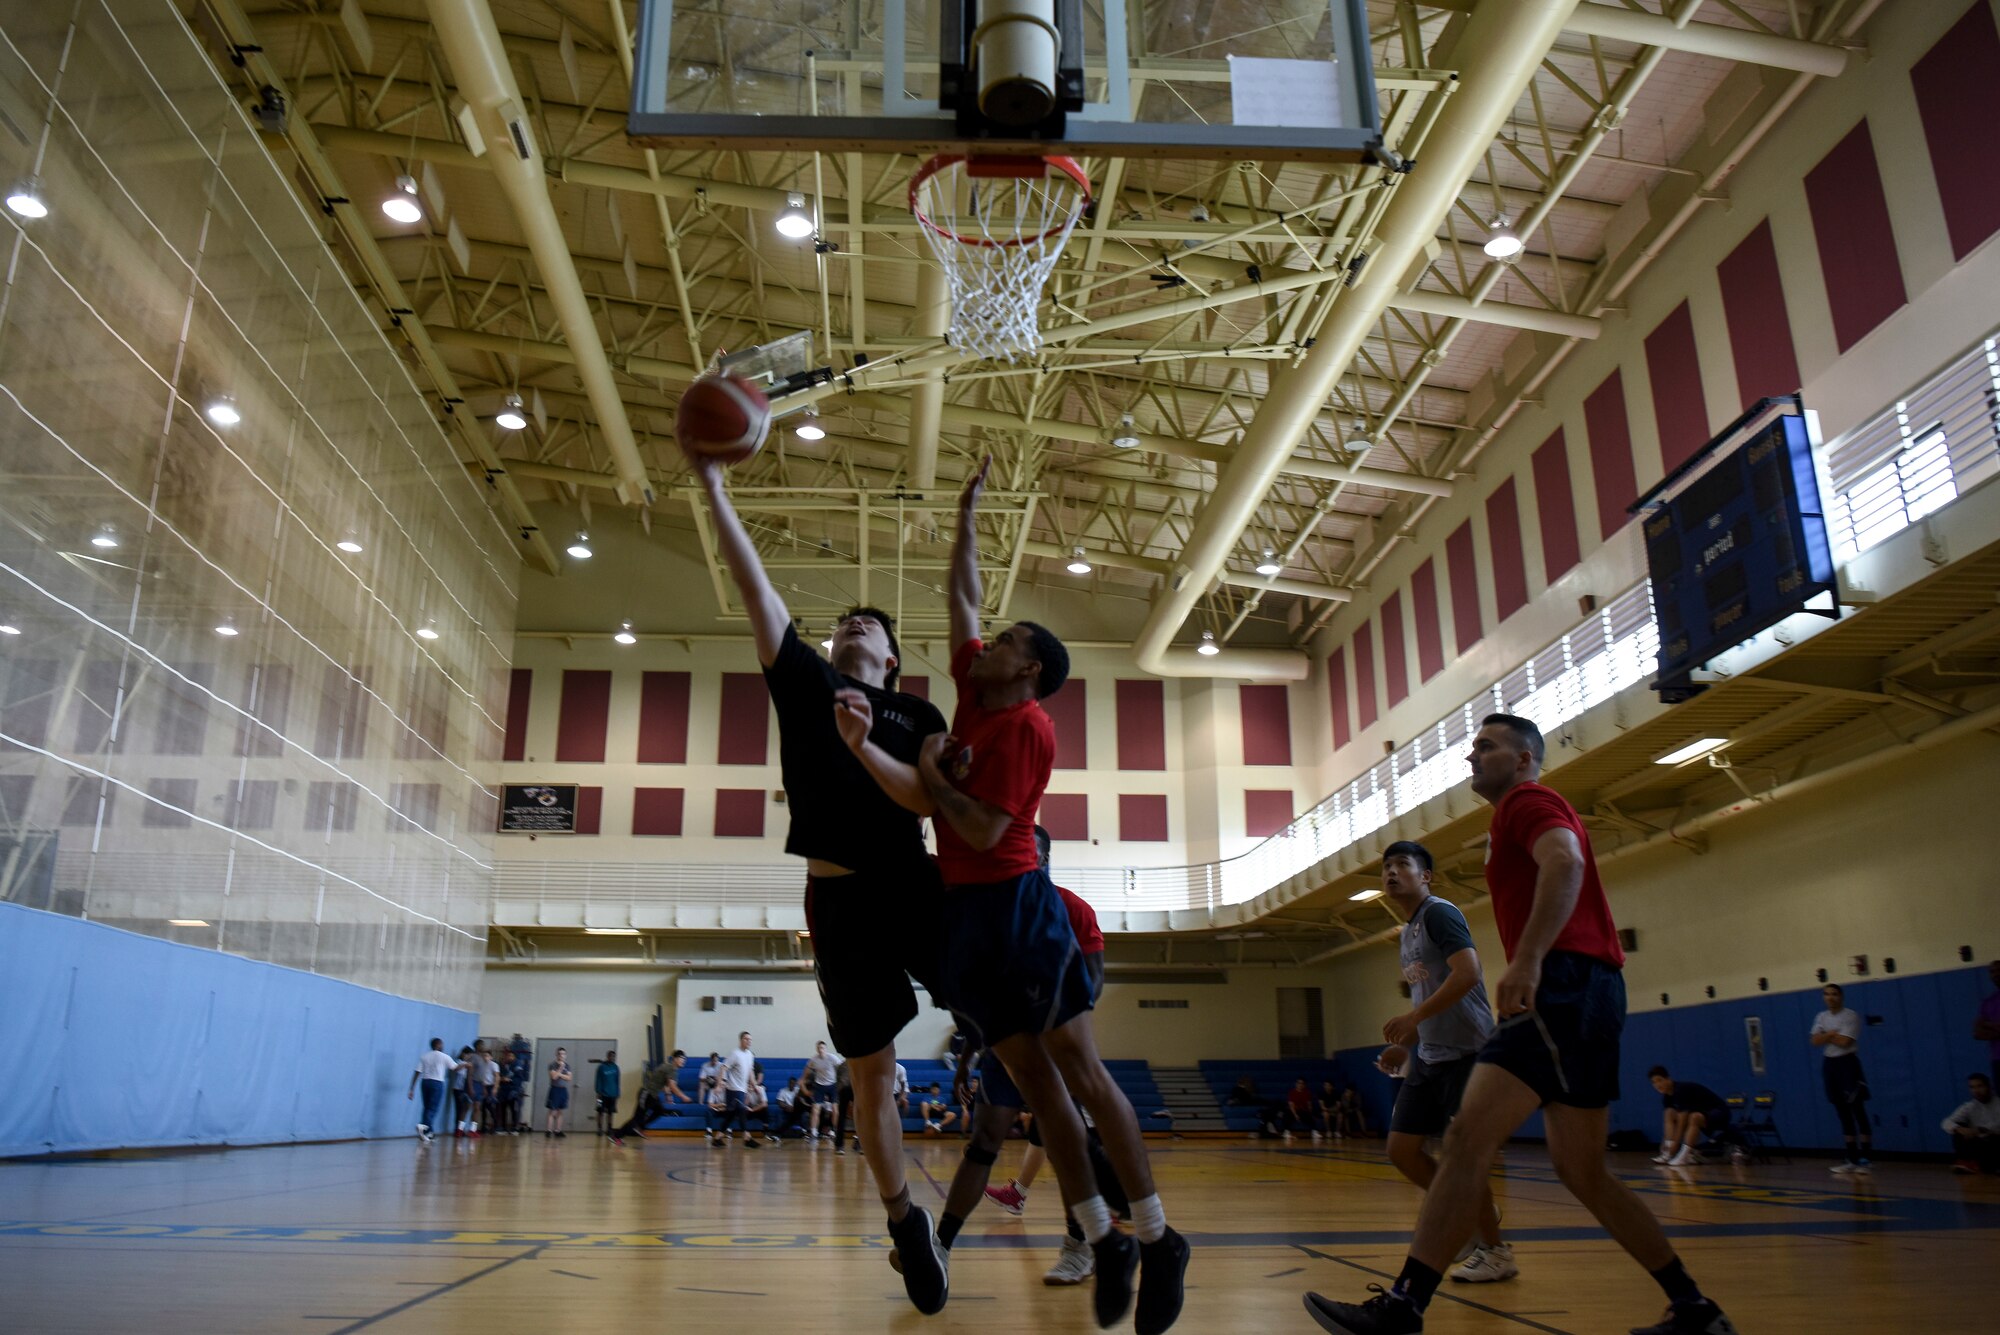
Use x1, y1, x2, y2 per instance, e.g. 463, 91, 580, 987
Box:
1134, 0, 1576, 679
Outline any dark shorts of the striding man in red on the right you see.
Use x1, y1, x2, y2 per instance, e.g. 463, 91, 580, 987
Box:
1480, 951, 1624, 1107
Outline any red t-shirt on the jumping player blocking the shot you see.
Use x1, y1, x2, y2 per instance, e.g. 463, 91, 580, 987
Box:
936, 640, 1056, 885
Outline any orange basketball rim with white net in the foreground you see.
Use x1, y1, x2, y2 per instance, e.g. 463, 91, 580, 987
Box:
910, 154, 1090, 362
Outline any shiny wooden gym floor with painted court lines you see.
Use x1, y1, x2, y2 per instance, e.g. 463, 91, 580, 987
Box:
0, 1133, 2000, 1335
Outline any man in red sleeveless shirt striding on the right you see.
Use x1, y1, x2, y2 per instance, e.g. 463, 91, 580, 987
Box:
1306, 713, 1736, 1335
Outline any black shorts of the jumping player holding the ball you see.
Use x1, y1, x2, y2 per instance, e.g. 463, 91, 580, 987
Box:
806, 857, 944, 1057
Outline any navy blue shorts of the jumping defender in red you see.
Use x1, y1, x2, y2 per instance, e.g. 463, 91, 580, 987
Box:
940, 871, 1092, 1047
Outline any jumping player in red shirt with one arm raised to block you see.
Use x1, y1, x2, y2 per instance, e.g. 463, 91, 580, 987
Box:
842, 456, 1188, 1335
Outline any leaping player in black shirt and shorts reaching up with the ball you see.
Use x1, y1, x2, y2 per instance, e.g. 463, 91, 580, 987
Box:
688, 454, 948, 1313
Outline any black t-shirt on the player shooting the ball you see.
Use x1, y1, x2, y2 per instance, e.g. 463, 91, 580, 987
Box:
764, 626, 944, 871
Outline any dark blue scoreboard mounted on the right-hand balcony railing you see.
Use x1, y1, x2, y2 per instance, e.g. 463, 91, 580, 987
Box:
1632, 398, 1838, 701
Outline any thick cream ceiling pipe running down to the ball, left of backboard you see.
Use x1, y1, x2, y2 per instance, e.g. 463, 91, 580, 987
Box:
428, 0, 652, 506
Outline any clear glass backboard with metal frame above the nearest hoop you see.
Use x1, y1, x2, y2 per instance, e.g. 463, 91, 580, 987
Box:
628, 0, 1382, 162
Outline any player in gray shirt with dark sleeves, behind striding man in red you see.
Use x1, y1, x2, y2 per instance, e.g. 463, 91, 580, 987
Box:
1382, 839, 1520, 1283
